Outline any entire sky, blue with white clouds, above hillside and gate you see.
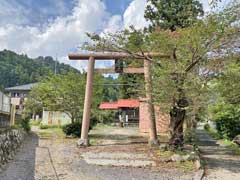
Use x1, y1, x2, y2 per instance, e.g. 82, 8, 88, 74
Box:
0, 0, 230, 69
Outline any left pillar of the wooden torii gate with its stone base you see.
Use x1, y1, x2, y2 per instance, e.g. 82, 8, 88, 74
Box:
77, 56, 95, 146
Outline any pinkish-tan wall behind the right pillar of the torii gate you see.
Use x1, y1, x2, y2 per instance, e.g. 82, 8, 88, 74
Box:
139, 102, 170, 134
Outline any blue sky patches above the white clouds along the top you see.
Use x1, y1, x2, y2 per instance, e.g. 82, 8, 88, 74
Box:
0, 0, 132, 26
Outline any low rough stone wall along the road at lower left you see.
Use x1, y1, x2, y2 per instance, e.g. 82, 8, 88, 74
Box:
0, 129, 26, 166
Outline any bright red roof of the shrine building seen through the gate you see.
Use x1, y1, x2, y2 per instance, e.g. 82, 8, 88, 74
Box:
99, 99, 140, 109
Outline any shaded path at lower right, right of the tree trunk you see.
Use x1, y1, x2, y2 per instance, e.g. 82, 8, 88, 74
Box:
197, 129, 240, 180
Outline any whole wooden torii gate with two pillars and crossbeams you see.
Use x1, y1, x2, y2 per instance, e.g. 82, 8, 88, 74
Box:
68, 53, 170, 146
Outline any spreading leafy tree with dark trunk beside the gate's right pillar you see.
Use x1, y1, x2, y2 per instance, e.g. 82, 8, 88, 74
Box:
85, 1, 240, 148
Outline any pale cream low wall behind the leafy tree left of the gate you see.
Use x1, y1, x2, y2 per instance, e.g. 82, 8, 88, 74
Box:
42, 111, 71, 126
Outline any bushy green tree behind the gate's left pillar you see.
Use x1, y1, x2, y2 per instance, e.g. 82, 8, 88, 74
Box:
26, 72, 102, 122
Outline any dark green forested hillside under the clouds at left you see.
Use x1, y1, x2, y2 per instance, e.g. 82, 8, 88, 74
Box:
0, 50, 77, 89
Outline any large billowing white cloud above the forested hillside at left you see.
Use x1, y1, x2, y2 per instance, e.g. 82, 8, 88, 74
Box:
0, 0, 109, 67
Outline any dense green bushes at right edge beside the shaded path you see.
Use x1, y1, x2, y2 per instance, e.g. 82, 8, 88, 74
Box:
210, 59, 240, 140
